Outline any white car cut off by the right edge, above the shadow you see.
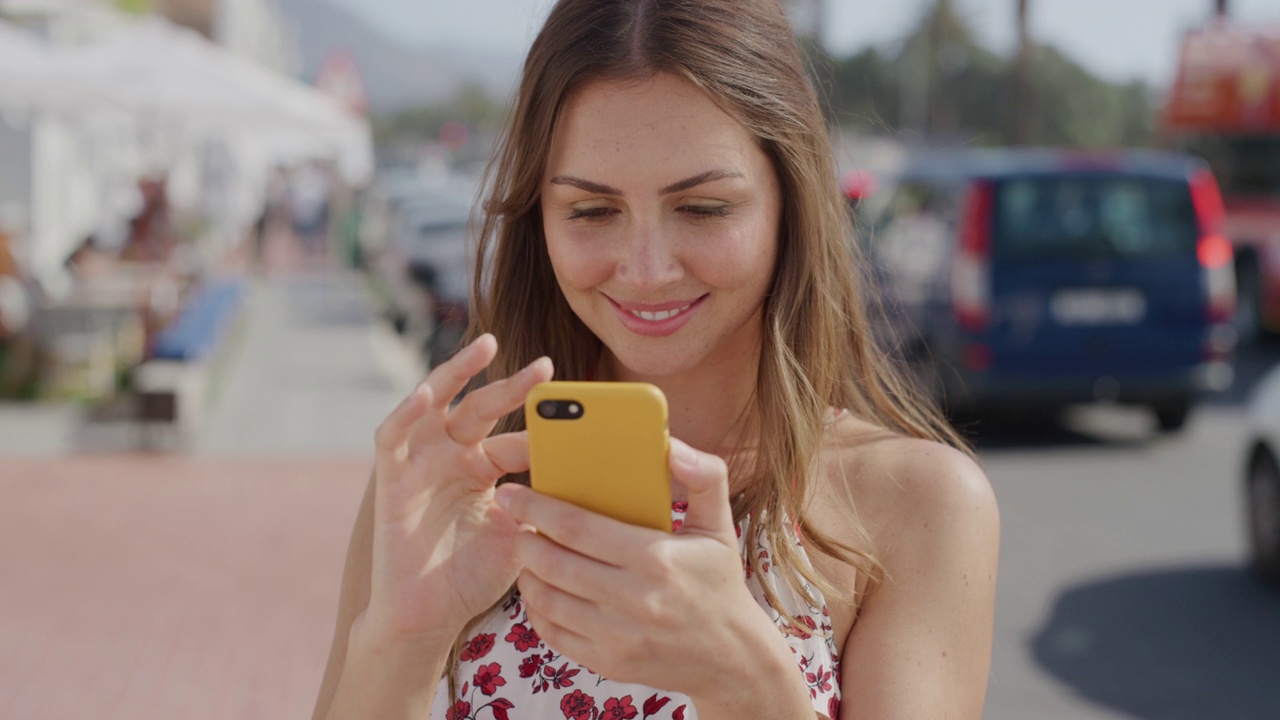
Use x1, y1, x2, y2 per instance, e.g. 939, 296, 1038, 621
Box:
1244, 369, 1280, 585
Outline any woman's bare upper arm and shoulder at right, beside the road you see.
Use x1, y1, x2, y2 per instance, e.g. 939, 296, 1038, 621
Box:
840, 441, 1000, 720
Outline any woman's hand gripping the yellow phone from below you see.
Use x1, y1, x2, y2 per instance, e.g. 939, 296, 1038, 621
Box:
498, 439, 773, 700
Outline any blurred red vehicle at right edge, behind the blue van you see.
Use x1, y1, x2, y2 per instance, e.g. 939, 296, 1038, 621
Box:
1164, 17, 1280, 342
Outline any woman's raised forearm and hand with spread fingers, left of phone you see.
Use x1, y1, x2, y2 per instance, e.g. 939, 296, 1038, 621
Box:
312, 334, 552, 720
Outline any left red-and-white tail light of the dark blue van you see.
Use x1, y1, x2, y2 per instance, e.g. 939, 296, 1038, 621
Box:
951, 181, 996, 332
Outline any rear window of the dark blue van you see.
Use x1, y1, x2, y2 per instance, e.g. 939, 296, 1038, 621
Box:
992, 174, 1198, 260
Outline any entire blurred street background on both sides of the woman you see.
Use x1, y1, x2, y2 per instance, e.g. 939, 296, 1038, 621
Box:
0, 0, 1280, 720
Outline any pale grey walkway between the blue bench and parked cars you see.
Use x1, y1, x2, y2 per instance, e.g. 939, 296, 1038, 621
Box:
195, 270, 422, 457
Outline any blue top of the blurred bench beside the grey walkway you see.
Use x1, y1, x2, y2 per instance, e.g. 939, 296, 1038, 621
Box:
151, 278, 246, 363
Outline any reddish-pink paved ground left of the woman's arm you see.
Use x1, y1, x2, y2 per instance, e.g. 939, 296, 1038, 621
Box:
0, 456, 369, 720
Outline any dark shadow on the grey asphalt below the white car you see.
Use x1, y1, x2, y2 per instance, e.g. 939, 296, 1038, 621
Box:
1032, 565, 1280, 720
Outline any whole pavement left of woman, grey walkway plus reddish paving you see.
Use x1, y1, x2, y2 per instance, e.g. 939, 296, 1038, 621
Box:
0, 263, 430, 720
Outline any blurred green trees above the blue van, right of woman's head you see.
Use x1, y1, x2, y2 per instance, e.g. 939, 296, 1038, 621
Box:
809, 0, 1156, 146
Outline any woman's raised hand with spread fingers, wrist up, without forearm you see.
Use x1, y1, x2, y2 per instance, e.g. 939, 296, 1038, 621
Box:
357, 334, 552, 642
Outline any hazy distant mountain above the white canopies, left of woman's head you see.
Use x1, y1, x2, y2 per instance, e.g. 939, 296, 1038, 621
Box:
276, 0, 520, 114
